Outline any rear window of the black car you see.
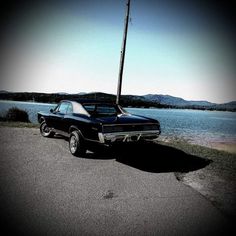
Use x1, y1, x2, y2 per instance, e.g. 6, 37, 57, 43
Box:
83, 104, 121, 116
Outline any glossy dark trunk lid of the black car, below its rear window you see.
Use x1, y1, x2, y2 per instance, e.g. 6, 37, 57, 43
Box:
94, 114, 157, 124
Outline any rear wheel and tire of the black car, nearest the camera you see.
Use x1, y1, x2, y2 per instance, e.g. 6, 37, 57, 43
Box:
69, 131, 86, 156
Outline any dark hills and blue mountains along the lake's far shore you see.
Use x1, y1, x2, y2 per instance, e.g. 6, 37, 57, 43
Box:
0, 91, 236, 111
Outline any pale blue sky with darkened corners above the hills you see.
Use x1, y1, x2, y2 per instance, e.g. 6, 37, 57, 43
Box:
0, 0, 236, 103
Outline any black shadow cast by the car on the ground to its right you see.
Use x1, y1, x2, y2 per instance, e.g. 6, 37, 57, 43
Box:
84, 143, 211, 173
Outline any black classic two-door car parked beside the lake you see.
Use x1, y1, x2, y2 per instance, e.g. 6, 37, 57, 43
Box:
38, 100, 161, 156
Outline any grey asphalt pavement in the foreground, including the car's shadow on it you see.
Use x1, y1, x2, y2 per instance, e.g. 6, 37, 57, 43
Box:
0, 128, 232, 235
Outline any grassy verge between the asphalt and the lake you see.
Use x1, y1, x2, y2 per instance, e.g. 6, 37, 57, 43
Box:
0, 122, 236, 219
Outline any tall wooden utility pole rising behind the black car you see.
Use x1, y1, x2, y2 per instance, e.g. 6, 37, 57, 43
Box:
116, 0, 130, 104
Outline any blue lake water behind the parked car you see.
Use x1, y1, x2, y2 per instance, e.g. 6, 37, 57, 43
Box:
0, 101, 236, 149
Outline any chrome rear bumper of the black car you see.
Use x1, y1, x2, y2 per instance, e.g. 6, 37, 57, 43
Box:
98, 130, 161, 143
